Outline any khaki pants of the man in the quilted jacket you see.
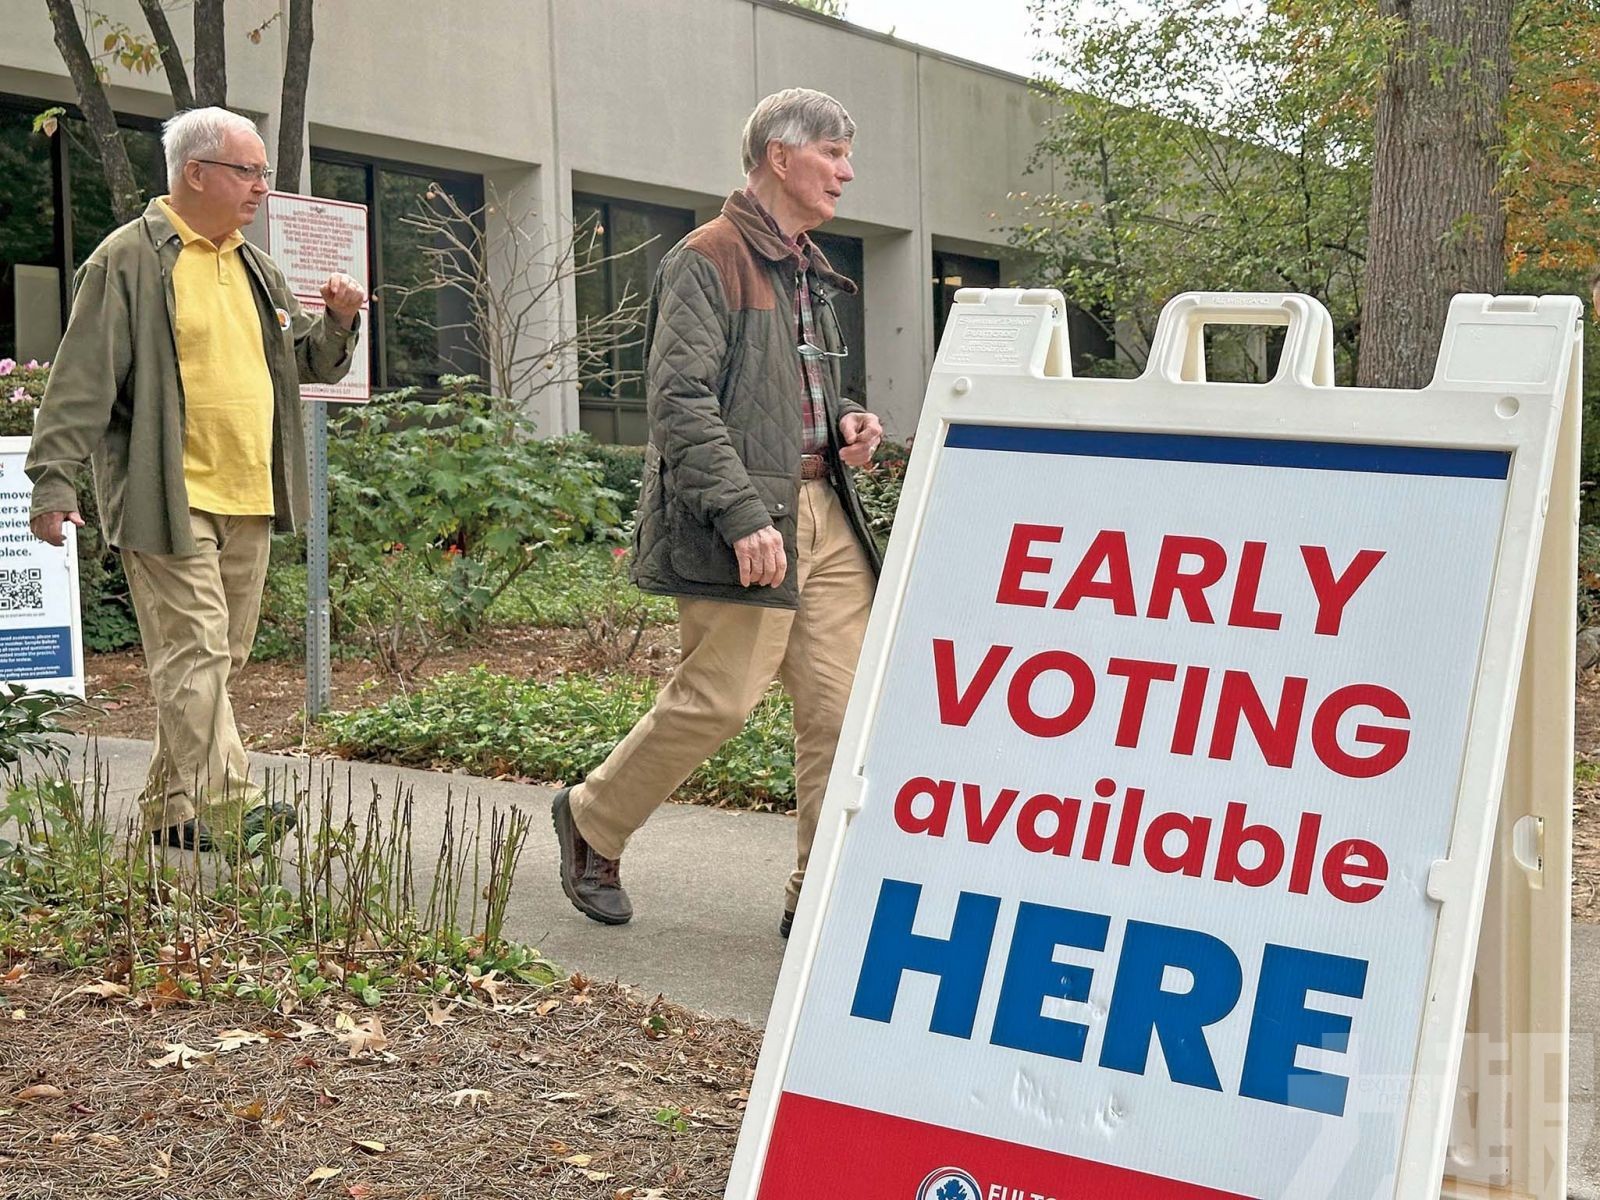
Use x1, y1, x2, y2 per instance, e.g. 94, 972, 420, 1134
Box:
571, 480, 874, 910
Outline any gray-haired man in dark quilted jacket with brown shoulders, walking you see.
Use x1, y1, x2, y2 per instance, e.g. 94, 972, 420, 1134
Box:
552, 88, 883, 938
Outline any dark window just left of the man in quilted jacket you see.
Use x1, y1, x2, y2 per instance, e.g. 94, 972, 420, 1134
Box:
573, 194, 694, 445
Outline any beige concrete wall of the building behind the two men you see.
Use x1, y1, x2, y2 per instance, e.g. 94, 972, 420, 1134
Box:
0, 0, 1075, 435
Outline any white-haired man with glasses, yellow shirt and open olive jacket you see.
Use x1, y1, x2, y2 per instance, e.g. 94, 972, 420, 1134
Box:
27, 109, 365, 850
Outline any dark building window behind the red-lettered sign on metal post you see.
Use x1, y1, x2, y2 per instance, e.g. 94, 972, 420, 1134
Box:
310, 149, 488, 389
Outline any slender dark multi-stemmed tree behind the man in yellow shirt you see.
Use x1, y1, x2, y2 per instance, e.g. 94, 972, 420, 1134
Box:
40, 0, 314, 221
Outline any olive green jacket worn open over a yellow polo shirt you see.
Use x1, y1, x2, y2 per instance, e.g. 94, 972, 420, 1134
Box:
27, 200, 357, 555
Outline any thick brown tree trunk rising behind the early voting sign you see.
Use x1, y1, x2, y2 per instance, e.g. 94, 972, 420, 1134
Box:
1357, 0, 1512, 387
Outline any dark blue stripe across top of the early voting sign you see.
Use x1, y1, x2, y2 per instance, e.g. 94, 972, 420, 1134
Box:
944, 424, 1510, 478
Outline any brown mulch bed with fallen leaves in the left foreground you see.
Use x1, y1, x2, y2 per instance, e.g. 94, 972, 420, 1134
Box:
0, 958, 760, 1200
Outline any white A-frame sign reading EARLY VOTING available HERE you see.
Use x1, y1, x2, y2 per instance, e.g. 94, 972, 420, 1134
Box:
728, 291, 1582, 1200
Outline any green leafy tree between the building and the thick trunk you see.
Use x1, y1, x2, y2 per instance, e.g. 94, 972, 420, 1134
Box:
1011, 0, 1389, 378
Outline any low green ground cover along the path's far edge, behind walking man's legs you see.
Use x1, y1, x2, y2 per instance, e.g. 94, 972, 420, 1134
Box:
323, 667, 794, 808
